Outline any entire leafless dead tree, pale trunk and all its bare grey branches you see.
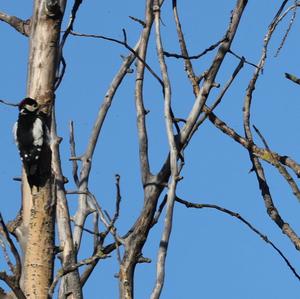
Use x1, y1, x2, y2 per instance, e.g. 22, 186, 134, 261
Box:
0, 0, 300, 299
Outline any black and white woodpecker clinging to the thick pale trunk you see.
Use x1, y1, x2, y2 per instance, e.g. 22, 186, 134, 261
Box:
13, 98, 46, 188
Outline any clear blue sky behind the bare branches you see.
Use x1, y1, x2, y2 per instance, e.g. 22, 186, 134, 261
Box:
0, 0, 300, 299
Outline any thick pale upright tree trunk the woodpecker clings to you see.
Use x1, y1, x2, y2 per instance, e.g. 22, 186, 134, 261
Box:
23, 0, 65, 299
